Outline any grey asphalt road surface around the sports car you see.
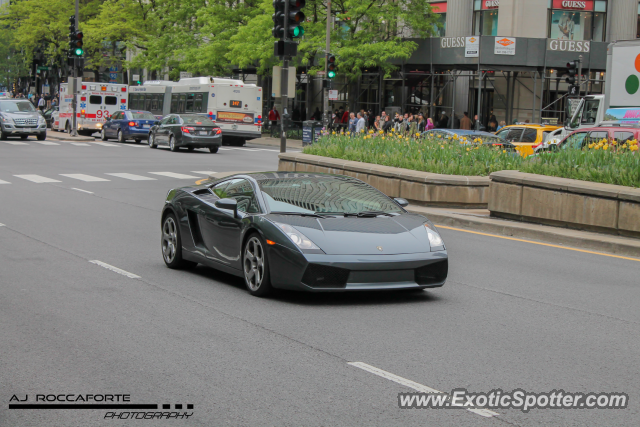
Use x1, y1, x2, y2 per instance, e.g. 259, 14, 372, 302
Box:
0, 135, 640, 427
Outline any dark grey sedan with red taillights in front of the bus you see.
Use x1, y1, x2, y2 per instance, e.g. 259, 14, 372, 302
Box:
149, 114, 222, 153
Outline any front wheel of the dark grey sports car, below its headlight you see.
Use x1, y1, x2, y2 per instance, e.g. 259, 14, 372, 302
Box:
242, 233, 273, 297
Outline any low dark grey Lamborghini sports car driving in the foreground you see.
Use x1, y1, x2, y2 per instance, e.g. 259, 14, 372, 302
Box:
161, 172, 448, 296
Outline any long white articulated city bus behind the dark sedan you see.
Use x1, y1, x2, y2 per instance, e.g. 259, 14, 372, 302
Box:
136, 77, 262, 145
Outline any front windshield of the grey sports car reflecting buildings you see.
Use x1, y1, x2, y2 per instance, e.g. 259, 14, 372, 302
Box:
259, 176, 402, 214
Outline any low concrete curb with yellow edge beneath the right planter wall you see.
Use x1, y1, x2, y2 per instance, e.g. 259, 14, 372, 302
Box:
406, 205, 640, 258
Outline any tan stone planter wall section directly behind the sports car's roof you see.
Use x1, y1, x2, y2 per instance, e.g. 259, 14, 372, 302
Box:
278, 153, 490, 208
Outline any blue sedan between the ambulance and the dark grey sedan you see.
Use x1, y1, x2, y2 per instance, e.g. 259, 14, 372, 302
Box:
100, 110, 157, 143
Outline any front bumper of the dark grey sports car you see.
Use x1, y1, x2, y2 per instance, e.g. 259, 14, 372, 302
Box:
269, 245, 448, 292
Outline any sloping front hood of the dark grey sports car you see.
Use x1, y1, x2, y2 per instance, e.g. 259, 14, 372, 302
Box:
268, 214, 431, 255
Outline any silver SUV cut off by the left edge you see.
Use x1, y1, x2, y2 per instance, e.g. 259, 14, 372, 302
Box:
0, 99, 47, 141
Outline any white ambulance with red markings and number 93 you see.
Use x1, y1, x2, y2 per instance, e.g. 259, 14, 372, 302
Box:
52, 82, 129, 136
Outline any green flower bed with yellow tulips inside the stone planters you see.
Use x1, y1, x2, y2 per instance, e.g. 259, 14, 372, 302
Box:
303, 131, 640, 187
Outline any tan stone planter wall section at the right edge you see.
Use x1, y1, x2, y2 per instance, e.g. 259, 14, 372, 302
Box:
488, 171, 640, 237
